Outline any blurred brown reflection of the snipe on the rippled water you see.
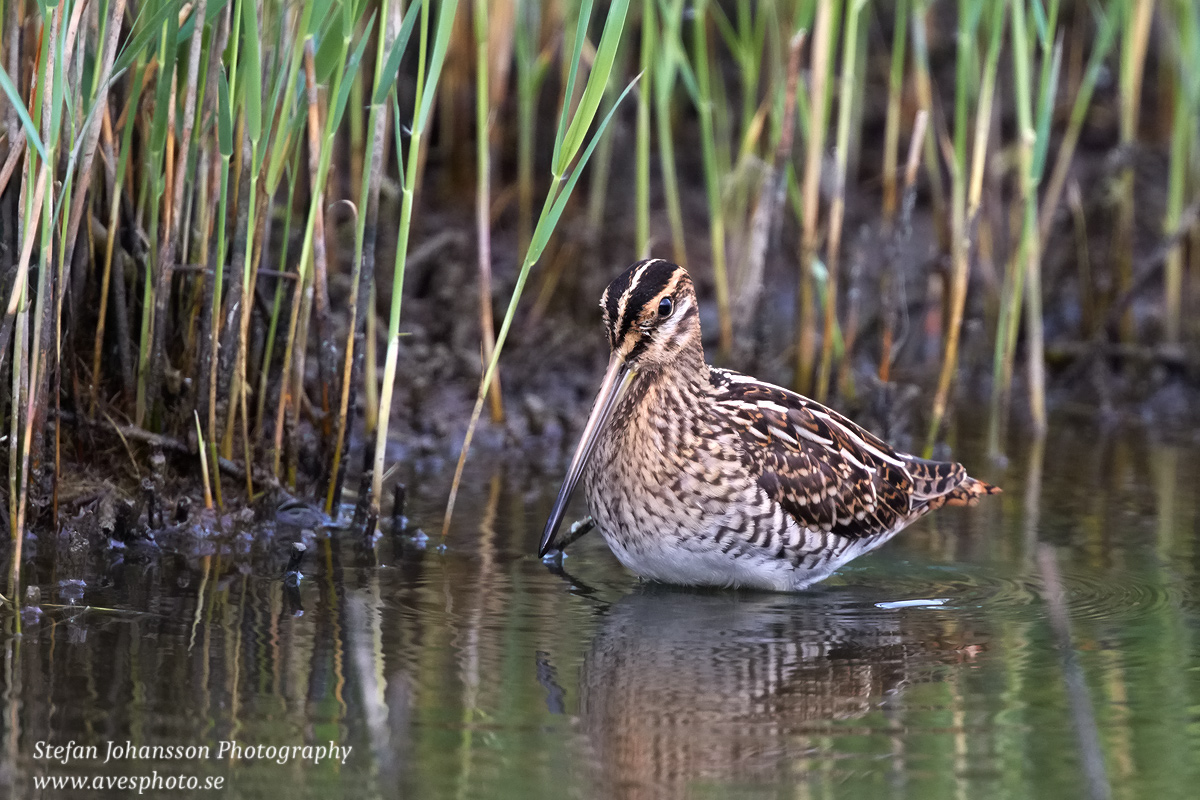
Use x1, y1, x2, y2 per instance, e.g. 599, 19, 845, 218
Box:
580, 587, 950, 798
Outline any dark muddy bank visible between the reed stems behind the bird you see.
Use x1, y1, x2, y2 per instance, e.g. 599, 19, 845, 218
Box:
31, 149, 1200, 558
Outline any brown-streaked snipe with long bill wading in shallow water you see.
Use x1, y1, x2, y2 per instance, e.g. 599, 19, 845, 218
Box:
538, 259, 1000, 591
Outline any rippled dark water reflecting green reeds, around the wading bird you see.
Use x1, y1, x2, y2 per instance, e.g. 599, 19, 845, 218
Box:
0, 422, 1200, 800
